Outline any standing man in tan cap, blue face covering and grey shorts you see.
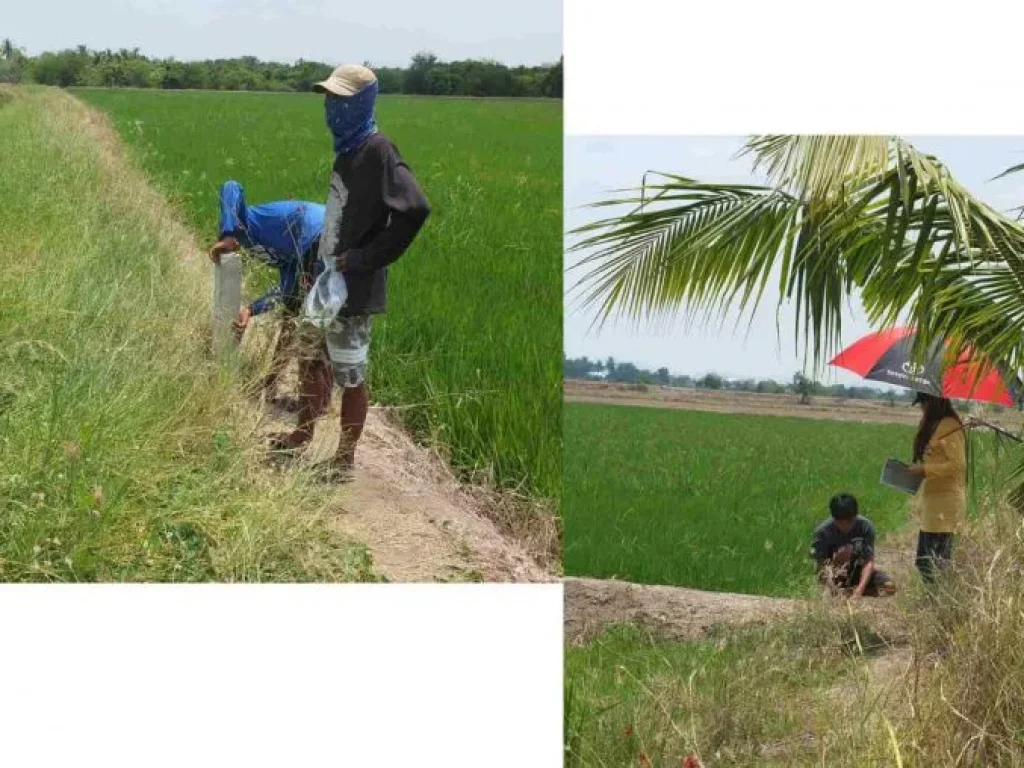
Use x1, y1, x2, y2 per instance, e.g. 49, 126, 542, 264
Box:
271, 65, 430, 479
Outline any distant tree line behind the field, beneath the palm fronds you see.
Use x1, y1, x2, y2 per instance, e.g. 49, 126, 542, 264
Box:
562, 356, 913, 402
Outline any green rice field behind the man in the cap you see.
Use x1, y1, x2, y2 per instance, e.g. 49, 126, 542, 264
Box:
75, 89, 562, 499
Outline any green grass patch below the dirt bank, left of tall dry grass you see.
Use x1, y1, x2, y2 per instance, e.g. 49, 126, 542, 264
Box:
565, 617, 864, 768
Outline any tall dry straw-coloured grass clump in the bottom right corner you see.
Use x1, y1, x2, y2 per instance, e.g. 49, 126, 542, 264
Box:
894, 507, 1024, 766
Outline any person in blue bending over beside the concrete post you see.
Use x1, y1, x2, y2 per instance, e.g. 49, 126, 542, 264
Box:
204, 181, 324, 397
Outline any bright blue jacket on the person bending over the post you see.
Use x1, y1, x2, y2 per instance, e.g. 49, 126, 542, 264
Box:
220, 180, 324, 315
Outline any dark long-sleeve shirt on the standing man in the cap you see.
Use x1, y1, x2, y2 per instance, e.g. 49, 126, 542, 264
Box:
321, 133, 430, 315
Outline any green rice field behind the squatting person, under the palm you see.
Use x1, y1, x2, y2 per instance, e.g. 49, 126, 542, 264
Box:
563, 402, 1003, 595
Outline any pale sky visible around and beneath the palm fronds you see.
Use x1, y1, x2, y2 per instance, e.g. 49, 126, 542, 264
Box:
564, 136, 1024, 384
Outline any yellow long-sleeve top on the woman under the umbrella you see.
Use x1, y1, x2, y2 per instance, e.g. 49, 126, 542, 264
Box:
914, 417, 967, 534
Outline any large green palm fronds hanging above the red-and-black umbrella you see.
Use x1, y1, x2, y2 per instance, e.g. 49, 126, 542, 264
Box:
573, 136, 1024, 376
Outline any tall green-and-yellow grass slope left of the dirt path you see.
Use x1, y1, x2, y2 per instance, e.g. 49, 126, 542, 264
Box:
0, 88, 373, 581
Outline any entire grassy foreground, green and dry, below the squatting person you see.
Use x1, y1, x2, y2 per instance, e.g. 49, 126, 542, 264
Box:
566, 505, 1024, 768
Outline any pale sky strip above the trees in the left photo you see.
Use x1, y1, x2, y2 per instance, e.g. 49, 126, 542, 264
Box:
6, 0, 562, 67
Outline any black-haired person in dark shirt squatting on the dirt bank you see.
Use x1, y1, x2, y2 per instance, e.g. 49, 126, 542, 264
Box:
811, 494, 896, 599
